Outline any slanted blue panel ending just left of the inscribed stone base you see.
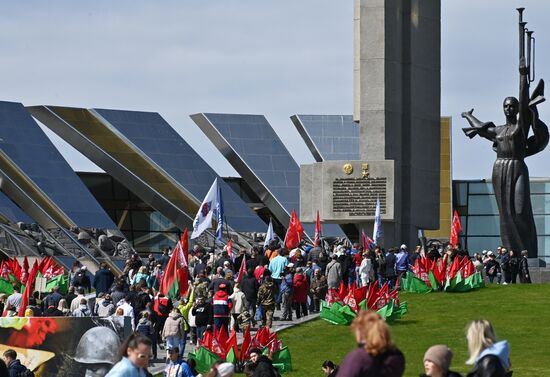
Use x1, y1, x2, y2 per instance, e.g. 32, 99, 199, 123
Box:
196, 113, 343, 236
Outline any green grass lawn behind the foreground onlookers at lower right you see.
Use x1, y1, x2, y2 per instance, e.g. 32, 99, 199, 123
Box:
280, 285, 550, 377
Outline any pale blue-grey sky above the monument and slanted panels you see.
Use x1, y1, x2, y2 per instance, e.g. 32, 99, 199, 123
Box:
0, 0, 550, 179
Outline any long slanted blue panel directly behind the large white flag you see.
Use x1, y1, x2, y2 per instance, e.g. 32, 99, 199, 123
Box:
94, 109, 266, 232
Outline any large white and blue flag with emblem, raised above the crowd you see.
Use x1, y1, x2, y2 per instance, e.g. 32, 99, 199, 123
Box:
191, 178, 223, 241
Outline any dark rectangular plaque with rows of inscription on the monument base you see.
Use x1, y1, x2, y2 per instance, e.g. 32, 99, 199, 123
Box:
332, 177, 387, 217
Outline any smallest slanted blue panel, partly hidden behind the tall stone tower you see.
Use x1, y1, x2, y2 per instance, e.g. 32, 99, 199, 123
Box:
292, 115, 360, 160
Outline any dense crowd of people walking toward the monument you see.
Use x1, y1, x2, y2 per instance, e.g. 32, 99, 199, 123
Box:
0, 240, 530, 376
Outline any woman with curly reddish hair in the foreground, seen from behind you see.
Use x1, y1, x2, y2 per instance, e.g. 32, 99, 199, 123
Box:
337, 311, 405, 377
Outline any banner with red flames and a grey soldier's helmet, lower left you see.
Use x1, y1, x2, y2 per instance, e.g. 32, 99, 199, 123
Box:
0, 317, 130, 377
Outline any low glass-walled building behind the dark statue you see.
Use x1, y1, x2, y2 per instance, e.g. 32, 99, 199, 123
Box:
453, 178, 550, 263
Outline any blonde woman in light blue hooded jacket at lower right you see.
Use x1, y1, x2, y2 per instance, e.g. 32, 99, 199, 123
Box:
466, 319, 512, 377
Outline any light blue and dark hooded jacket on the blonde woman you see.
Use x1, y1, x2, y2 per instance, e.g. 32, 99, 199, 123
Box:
468, 340, 511, 377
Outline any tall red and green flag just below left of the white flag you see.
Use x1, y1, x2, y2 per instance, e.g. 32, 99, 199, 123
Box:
159, 228, 189, 299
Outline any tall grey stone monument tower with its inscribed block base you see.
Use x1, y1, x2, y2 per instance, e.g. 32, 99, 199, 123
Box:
300, 0, 441, 247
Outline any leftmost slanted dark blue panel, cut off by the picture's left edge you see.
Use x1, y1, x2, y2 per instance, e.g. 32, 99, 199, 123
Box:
0, 101, 116, 228
